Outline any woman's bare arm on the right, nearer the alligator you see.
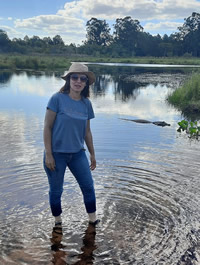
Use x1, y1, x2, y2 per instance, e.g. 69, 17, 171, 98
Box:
85, 120, 96, 170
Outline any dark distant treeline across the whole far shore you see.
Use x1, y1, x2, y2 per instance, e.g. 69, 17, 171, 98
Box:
0, 12, 200, 58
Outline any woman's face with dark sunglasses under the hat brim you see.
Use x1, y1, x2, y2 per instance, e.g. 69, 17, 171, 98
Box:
70, 74, 88, 93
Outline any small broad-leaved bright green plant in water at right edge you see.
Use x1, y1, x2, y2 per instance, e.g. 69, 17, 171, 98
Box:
177, 120, 200, 139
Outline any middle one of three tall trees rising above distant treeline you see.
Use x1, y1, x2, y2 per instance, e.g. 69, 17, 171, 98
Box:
114, 16, 143, 53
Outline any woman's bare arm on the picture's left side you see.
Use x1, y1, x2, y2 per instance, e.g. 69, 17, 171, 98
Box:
43, 109, 56, 170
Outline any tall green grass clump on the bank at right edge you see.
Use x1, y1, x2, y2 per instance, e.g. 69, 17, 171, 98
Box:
167, 73, 200, 115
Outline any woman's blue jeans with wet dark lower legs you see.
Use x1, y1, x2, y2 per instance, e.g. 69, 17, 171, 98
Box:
44, 150, 96, 216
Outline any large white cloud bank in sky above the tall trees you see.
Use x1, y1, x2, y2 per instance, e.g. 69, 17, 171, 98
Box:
58, 0, 200, 21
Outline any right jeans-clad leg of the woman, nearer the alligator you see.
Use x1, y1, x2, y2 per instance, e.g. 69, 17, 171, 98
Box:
68, 150, 96, 214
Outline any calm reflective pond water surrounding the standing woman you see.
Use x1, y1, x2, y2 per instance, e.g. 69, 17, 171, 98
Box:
0, 66, 200, 265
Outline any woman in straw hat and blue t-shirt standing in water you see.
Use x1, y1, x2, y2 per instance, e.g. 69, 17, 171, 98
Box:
44, 63, 99, 226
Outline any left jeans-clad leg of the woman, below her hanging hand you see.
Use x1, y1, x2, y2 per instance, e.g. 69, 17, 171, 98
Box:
44, 153, 67, 216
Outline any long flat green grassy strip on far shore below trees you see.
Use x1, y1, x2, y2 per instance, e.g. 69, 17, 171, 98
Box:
0, 54, 200, 70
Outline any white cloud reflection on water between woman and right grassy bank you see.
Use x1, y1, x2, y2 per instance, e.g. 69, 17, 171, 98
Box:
92, 83, 177, 122
